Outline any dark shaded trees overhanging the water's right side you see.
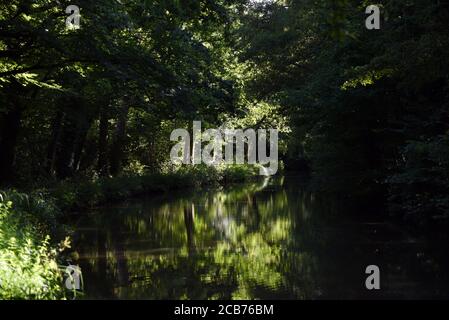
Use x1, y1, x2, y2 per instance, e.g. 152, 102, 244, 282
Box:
236, 0, 449, 220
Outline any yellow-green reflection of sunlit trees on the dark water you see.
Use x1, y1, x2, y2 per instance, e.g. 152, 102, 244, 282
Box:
74, 178, 326, 299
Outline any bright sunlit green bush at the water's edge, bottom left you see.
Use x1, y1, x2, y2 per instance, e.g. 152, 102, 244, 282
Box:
0, 201, 64, 299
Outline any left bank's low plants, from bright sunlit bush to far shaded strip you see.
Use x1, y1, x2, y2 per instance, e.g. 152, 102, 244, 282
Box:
0, 166, 258, 299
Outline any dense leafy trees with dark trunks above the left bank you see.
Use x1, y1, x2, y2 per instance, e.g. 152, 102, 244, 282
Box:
0, 0, 247, 184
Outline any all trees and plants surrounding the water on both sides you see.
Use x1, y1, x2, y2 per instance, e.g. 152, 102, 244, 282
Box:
0, 0, 449, 298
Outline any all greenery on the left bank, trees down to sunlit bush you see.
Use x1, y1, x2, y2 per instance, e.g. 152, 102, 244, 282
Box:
0, 0, 260, 299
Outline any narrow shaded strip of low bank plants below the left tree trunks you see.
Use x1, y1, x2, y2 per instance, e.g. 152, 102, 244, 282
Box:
48, 165, 258, 211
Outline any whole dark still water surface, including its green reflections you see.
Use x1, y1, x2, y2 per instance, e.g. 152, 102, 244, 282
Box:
74, 178, 449, 299
